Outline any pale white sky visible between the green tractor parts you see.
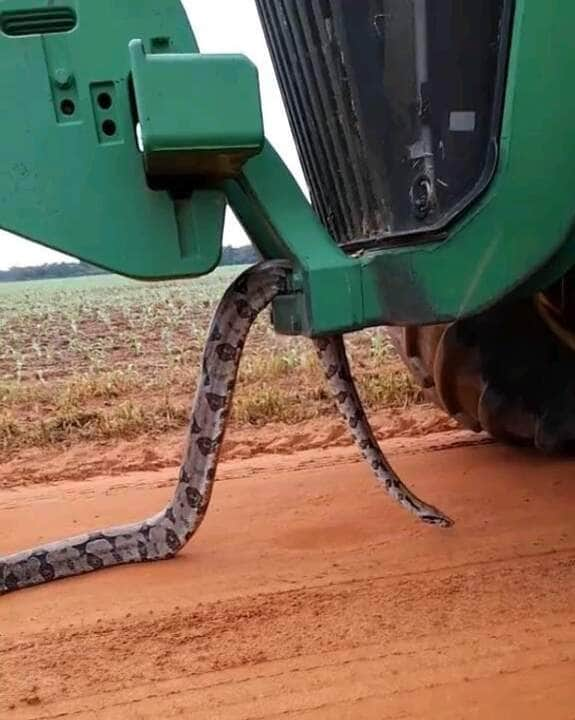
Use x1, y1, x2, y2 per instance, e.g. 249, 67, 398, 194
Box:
0, 0, 305, 270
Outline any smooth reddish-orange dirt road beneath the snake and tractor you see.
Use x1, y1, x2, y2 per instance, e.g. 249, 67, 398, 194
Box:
0, 434, 575, 720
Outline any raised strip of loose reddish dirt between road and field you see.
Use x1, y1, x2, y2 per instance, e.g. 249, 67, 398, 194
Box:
0, 405, 464, 488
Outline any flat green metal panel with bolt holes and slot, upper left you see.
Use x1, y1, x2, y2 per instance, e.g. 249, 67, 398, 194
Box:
0, 0, 225, 278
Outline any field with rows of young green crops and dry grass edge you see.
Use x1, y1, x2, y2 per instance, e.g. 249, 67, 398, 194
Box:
0, 267, 420, 453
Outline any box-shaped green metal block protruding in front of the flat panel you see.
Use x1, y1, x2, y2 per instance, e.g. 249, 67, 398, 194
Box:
130, 40, 264, 183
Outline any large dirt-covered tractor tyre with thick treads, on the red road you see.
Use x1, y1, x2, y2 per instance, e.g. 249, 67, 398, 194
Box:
389, 286, 575, 453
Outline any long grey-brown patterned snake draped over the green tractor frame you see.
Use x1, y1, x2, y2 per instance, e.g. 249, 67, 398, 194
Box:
0, 261, 452, 595
